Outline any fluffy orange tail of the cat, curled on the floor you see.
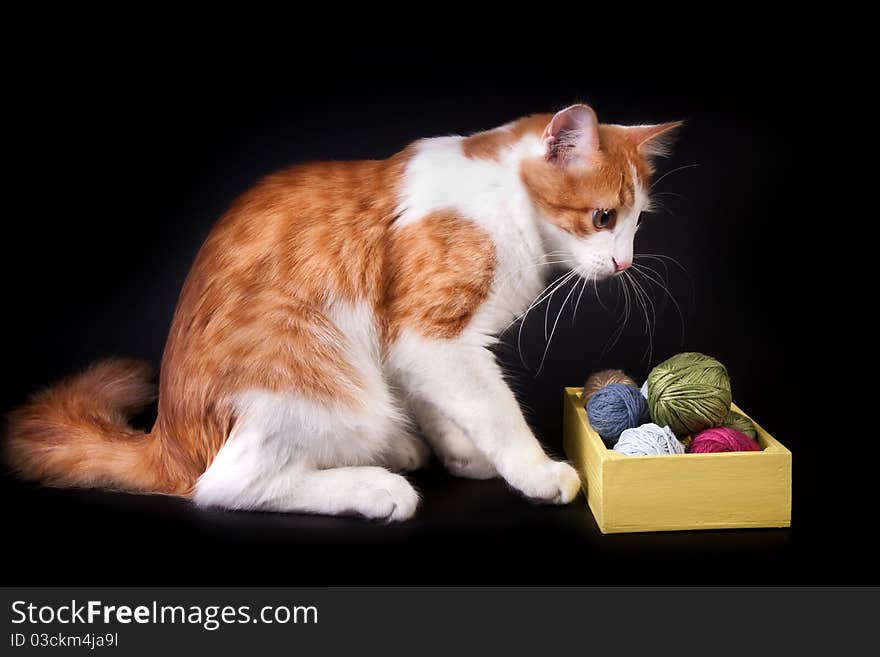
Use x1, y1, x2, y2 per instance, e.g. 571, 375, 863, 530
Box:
3, 359, 170, 492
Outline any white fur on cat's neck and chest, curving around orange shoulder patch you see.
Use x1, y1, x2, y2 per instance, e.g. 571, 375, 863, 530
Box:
395, 137, 548, 339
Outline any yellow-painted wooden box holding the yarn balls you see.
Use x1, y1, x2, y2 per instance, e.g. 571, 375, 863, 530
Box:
563, 388, 791, 534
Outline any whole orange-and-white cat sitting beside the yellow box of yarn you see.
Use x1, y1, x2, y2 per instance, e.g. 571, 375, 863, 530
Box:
4, 104, 681, 521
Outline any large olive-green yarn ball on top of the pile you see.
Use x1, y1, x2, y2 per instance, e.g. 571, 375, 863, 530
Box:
647, 352, 731, 436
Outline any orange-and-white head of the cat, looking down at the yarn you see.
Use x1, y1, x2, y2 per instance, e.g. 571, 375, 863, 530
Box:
520, 105, 681, 279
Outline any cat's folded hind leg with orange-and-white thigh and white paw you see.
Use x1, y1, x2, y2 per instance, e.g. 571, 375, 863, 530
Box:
194, 300, 428, 520
